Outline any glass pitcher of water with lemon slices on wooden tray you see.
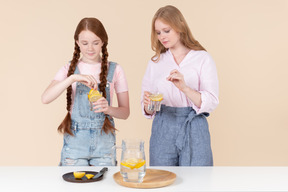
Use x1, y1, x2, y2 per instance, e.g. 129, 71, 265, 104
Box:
120, 139, 146, 183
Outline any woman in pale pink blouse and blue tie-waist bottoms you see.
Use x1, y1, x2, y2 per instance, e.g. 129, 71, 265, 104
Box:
142, 5, 219, 166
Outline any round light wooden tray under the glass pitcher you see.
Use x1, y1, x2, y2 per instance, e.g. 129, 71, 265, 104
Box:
113, 169, 176, 189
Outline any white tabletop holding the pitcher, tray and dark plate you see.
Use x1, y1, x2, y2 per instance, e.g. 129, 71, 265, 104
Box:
0, 166, 288, 192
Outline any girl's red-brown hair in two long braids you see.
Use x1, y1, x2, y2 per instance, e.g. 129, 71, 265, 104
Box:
58, 18, 116, 136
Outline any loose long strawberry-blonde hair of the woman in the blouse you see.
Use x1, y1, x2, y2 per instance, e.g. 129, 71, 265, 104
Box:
151, 5, 206, 62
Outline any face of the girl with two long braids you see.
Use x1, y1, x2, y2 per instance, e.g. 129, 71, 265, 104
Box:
76, 30, 103, 63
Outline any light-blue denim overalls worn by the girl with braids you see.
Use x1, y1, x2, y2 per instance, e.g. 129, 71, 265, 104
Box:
60, 62, 116, 166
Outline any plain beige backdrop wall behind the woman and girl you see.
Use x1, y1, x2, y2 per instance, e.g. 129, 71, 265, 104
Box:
0, 0, 288, 166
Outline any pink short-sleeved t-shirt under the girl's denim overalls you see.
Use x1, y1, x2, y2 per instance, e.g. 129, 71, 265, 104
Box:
54, 60, 128, 109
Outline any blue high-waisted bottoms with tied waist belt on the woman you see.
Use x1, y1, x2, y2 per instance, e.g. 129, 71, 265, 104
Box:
150, 105, 213, 166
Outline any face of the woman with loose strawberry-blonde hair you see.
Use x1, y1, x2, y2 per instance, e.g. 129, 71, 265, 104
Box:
155, 19, 181, 49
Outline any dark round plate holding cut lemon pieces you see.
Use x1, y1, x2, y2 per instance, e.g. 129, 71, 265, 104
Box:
62, 171, 103, 183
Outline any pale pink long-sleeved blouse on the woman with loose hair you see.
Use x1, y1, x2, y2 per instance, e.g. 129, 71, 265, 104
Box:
141, 50, 219, 118
